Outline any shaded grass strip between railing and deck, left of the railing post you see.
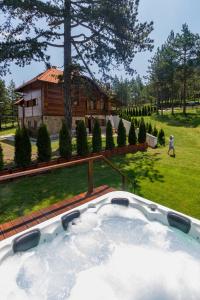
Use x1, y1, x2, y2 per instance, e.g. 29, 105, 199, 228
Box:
0, 165, 87, 223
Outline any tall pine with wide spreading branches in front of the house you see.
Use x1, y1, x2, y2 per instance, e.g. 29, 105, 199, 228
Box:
0, 0, 153, 131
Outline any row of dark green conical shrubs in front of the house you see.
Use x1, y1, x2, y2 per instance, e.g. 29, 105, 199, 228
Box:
0, 118, 165, 170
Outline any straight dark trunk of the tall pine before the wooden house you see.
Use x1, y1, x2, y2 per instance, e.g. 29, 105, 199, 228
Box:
63, 0, 72, 135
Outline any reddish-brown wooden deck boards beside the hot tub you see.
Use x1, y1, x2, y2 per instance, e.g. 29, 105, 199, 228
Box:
0, 185, 114, 241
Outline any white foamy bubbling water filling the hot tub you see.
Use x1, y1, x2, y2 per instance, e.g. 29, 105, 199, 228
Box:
0, 205, 200, 300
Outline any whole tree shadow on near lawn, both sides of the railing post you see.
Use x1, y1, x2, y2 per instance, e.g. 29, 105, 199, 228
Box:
0, 153, 163, 223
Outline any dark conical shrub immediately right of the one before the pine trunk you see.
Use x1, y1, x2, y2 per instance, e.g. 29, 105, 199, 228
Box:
76, 121, 89, 156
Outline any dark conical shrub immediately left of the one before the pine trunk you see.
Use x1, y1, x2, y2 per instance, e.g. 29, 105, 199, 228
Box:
36, 124, 51, 162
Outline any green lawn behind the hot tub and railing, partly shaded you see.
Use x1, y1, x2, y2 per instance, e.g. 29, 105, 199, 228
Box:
0, 111, 200, 223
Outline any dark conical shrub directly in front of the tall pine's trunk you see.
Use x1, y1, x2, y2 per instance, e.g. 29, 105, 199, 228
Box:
59, 122, 72, 159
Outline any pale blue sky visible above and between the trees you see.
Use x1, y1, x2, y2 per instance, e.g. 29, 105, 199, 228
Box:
2, 0, 200, 86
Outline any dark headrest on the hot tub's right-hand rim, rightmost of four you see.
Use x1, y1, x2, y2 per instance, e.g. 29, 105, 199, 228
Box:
167, 212, 191, 233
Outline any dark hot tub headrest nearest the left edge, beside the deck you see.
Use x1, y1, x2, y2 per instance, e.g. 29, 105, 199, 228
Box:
13, 229, 41, 253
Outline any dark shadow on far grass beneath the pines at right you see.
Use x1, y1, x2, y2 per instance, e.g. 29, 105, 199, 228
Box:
153, 113, 200, 128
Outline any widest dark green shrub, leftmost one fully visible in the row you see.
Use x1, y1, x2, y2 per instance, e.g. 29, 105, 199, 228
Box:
14, 127, 32, 167
